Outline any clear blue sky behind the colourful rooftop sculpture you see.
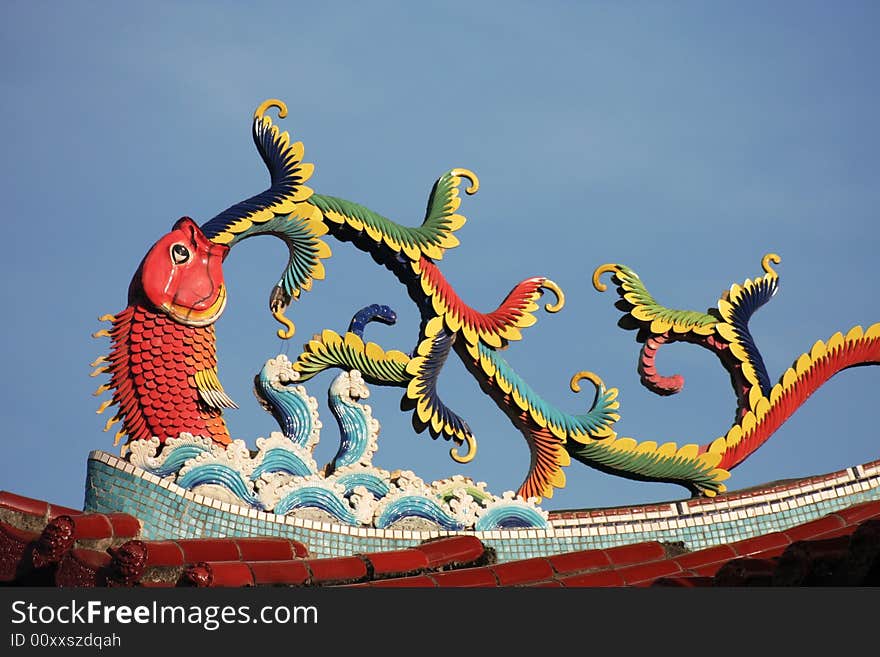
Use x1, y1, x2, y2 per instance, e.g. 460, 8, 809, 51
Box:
0, 1, 880, 509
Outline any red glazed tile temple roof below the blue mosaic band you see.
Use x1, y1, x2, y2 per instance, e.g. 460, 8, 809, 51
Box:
0, 492, 880, 587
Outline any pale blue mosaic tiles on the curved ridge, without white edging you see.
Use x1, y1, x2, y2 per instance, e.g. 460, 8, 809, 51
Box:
84, 459, 880, 561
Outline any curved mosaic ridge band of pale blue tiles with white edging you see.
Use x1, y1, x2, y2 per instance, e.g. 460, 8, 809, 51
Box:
84, 451, 880, 561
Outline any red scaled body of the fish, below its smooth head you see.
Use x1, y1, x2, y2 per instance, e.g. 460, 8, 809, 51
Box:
110, 306, 230, 444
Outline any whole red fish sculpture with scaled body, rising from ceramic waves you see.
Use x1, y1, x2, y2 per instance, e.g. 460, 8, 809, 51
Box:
96, 217, 236, 445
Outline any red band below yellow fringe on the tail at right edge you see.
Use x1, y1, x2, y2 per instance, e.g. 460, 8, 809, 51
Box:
718, 338, 880, 470
